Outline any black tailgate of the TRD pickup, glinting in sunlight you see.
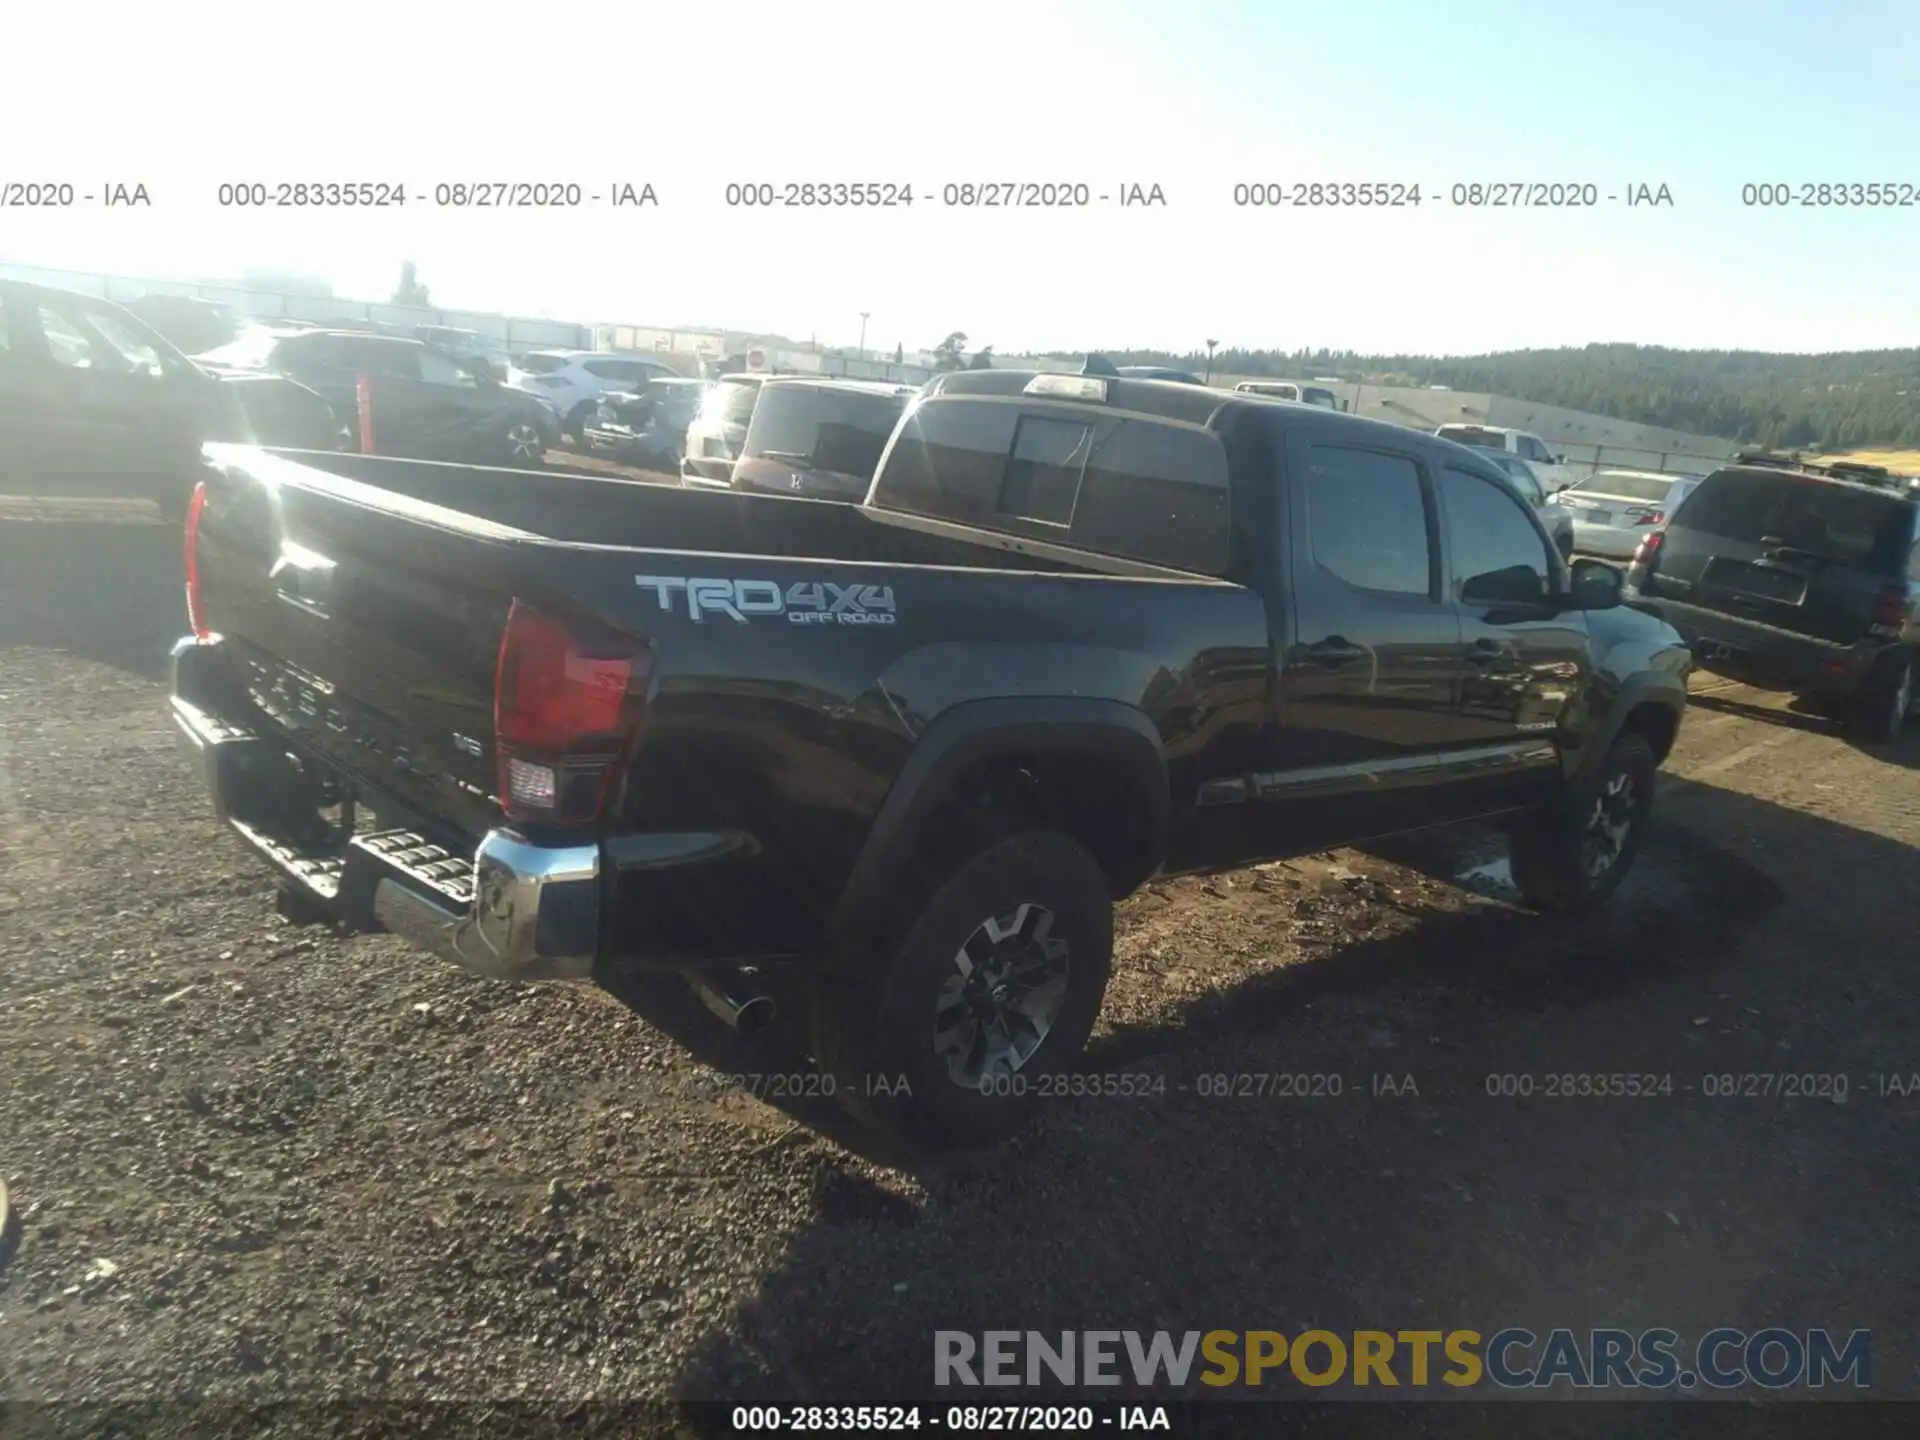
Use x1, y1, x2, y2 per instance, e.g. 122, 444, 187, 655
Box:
196, 451, 632, 839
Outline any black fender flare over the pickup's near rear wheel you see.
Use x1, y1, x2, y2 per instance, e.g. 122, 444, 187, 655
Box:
833, 695, 1171, 939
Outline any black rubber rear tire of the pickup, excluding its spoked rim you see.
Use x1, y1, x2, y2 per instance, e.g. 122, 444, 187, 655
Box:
812, 831, 1114, 1148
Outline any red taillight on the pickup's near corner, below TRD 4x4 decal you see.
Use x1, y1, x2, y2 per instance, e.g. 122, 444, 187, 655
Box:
493, 599, 649, 824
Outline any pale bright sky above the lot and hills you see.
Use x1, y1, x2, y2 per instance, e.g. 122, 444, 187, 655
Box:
0, 0, 1920, 355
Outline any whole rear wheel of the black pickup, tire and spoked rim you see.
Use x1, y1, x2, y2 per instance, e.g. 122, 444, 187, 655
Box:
814, 831, 1114, 1146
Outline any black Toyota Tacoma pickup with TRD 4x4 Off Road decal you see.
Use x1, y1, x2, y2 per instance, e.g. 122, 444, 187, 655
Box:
173, 371, 1690, 1142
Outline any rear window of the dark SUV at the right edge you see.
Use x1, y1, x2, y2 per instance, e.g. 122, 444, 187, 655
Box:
1674, 470, 1912, 574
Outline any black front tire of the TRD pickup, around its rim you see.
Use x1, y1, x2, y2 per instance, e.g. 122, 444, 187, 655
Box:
1511, 730, 1659, 914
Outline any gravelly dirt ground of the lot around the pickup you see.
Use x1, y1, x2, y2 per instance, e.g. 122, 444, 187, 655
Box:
0, 513, 1920, 1434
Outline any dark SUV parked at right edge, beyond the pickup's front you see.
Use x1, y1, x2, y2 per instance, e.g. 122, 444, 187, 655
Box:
1626, 455, 1920, 741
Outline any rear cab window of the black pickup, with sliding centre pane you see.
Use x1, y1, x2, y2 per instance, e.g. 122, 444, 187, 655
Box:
874, 396, 1229, 574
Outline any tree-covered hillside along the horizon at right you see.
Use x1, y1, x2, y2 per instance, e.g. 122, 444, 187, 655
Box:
1100, 346, 1920, 449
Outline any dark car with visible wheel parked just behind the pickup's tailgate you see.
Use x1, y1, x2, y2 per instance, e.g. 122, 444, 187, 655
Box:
196, 328, 561, 467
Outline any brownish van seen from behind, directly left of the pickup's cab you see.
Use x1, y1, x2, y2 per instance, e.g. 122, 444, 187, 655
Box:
732, 380, 920, 501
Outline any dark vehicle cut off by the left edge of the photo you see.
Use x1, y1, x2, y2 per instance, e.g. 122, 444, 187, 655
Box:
0, 280, 338, 515
